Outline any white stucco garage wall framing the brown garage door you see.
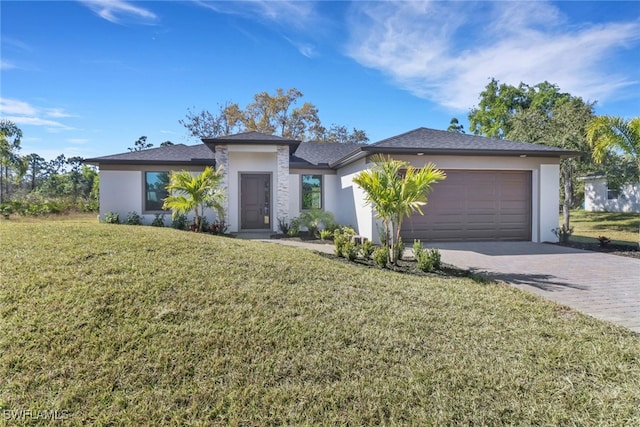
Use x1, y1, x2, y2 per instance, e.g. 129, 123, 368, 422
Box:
338, 155, 560, 242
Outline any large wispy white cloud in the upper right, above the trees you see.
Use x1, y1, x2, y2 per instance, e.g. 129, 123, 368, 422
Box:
348, 1, 640, 110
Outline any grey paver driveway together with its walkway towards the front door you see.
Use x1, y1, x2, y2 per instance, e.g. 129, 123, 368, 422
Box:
252, 239, 640, 333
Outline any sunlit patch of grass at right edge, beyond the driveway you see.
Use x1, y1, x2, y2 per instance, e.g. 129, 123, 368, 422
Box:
560, 210, 640, 246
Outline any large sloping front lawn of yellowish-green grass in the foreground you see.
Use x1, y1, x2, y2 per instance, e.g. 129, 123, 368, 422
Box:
0, 219, 640, 425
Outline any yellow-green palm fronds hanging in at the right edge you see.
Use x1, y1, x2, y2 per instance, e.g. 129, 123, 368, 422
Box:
587, 116, 640, 168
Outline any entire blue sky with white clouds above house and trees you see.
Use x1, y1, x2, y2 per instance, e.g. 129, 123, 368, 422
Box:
0, 0, 640, 159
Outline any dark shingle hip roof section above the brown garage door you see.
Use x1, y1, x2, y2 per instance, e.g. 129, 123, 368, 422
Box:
363, 128, 577, 157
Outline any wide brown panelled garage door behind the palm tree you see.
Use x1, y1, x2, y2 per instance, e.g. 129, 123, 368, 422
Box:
402, 170, 531, 243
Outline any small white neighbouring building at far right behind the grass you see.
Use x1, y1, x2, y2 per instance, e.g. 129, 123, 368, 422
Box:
582, 174, 640, 212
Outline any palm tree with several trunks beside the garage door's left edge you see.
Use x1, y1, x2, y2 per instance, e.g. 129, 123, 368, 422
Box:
353, 155, 446, 264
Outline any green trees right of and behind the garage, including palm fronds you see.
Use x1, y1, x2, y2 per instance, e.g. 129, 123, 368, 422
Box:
448, 79, 640, 233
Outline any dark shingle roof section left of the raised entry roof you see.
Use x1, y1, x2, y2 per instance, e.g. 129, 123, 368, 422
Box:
85, 144, 215, 165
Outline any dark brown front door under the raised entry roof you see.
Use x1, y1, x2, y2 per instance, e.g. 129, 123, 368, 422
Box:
240, 174, 271, 230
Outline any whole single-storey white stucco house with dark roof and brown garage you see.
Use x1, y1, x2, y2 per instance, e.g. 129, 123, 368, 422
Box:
87, 128, 575, 242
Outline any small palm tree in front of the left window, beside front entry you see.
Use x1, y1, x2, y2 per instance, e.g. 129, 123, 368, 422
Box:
163, 166, 224, 231
